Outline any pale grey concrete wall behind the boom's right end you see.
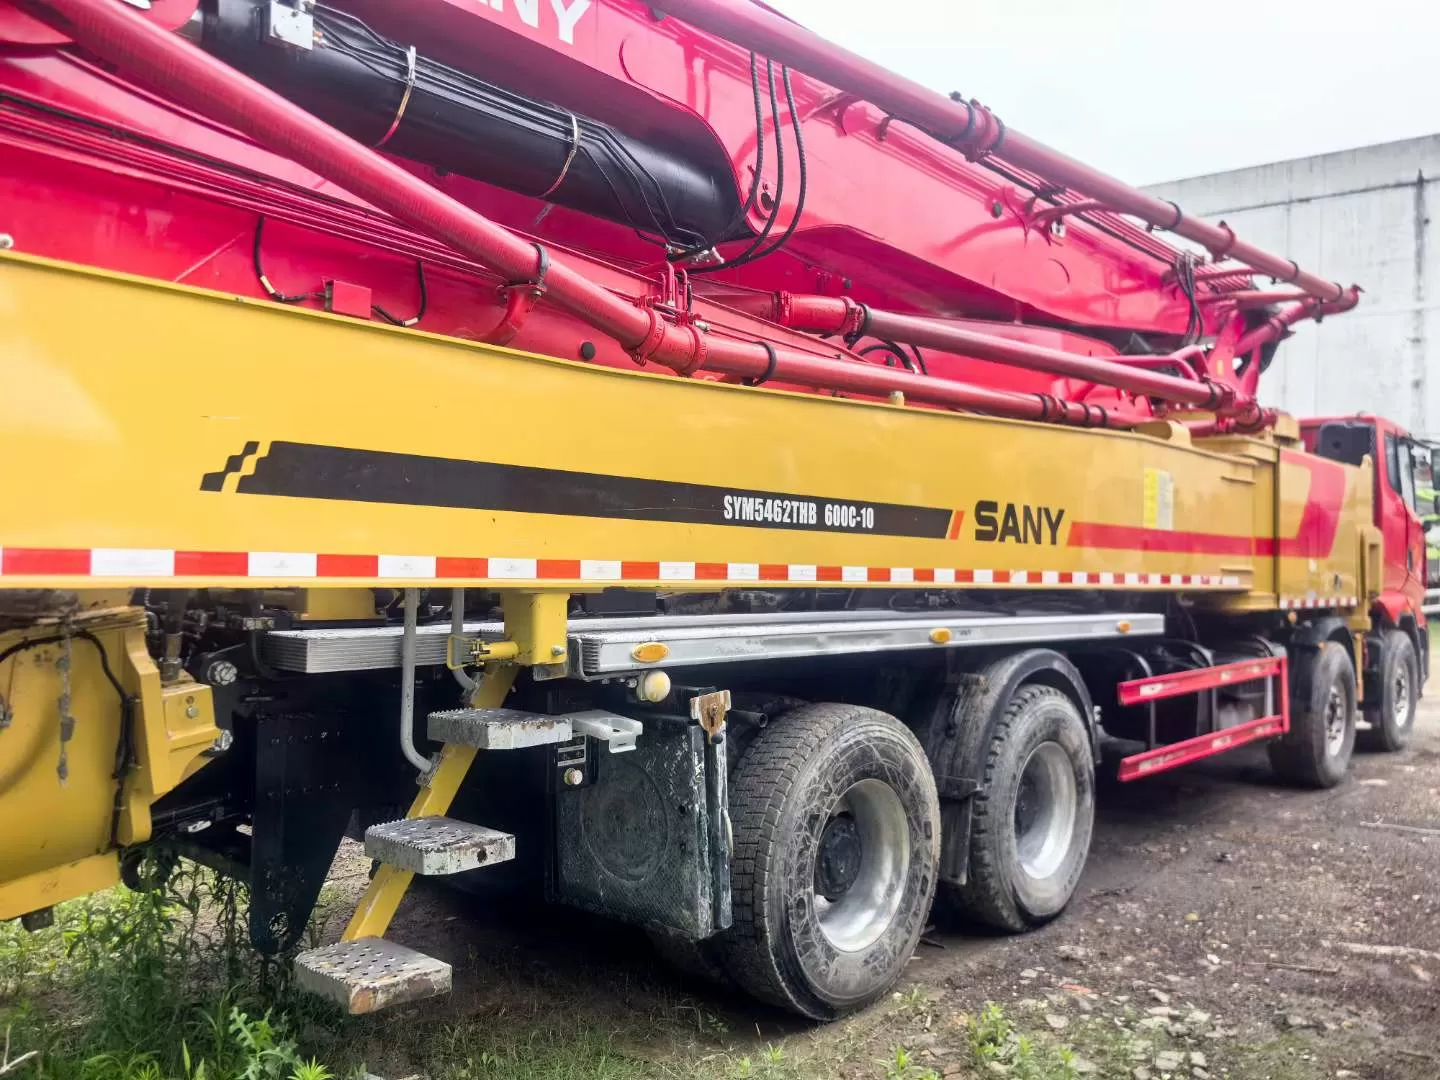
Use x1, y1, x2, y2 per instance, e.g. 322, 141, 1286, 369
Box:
1148, 135, 1440, 438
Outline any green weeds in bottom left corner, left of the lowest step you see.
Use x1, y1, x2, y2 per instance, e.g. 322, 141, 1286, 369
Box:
0, 867, 331, 1080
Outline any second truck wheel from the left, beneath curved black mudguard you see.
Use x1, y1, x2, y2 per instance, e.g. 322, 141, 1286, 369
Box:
955, 694, 1094, 933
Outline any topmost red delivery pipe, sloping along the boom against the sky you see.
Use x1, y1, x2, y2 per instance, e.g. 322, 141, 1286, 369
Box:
649, 0, 1354, 308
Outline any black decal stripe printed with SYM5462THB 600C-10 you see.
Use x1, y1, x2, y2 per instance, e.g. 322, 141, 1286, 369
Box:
230, 442, 950, 540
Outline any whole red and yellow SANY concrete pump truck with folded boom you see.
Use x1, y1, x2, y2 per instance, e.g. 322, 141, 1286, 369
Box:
0, 0, 1434, 1018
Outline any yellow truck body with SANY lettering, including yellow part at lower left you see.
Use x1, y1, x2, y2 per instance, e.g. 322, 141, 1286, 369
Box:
0, 253, 1380, 919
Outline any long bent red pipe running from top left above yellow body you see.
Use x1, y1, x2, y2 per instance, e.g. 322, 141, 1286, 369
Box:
24, 0, 1148, 426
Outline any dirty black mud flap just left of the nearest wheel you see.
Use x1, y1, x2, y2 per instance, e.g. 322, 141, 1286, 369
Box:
552, 716, 730, 939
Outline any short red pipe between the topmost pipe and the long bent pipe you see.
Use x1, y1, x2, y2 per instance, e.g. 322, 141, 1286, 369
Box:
726, 292, 1248, 410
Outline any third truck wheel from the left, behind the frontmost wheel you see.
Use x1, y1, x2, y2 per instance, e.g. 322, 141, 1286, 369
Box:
1269, 641, 1355, 788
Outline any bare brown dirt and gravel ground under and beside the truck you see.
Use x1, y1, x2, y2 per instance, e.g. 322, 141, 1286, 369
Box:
318, 704, 1440, 1080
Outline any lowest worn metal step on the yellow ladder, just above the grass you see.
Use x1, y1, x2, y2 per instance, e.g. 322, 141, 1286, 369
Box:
295, 937, 451, 1015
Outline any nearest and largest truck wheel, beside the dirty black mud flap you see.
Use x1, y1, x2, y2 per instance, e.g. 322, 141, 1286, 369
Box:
720, 704, 940, 1020
